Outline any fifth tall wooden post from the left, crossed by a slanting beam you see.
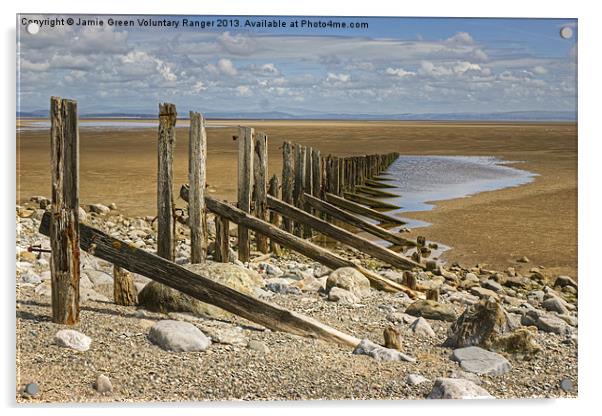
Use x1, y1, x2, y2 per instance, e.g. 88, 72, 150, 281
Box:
253, 133, 268, 253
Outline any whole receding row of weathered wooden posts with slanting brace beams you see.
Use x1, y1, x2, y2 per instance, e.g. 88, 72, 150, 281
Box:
40, 97, 423, 345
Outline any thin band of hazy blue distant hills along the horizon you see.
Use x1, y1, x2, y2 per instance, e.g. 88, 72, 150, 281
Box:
17, 110, 577, 121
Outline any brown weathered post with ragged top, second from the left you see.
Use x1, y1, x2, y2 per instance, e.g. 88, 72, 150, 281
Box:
157, 103, 177, 261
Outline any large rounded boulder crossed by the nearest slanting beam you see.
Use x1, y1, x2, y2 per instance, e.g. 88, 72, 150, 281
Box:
138, 263, 263, 319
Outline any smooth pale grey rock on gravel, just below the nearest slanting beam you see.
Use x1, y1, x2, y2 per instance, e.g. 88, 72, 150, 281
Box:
148, 320, 211, 352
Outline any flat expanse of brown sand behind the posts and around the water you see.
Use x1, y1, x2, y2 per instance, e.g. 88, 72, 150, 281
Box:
17, 120, 577, 276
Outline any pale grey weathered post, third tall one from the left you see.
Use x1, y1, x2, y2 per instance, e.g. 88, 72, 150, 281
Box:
188, 111, 207, 263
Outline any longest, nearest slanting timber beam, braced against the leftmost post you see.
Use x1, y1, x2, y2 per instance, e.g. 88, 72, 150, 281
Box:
40, 213, 360, 347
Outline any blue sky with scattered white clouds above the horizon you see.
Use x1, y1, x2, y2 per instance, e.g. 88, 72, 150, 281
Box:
17, 15, 577, 115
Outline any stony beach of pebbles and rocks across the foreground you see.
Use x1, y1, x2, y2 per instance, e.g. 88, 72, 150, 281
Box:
16, 197, 578, 403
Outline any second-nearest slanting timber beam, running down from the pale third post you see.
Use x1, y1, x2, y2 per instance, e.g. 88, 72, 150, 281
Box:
205, 196, 419, 299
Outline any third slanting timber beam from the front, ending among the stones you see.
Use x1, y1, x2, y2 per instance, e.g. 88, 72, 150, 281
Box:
268, 196, 424, 269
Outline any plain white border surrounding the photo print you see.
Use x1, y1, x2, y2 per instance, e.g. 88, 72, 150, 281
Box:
0, 0, 602, 415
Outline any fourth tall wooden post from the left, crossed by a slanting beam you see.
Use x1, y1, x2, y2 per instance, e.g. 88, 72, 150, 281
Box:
238, 127, 255, 262
